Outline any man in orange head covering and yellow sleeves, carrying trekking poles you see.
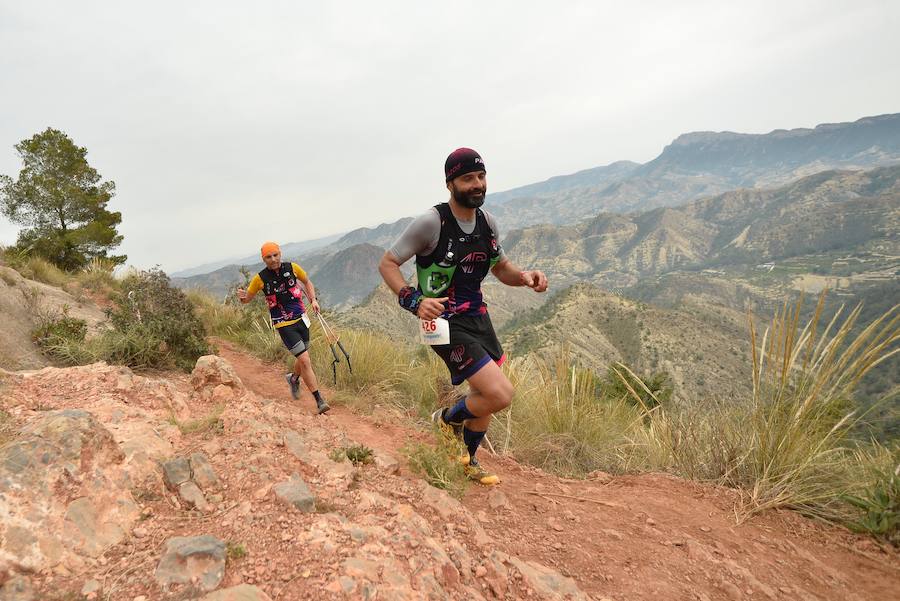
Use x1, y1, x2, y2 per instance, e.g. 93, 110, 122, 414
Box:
237, 242, 330, 413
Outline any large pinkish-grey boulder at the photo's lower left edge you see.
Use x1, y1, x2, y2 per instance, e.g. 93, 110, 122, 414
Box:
0, 409, 140, 571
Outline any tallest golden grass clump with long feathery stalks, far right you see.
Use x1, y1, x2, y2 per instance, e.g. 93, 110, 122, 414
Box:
729, 294, 900, 517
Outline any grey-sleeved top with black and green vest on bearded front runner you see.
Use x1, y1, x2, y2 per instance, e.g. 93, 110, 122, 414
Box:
390, 203, 505, 317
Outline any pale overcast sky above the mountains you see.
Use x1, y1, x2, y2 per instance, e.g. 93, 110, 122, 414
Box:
0, 0, 900, 271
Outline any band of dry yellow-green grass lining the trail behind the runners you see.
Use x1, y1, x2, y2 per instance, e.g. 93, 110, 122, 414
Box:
193, 290, 900, 543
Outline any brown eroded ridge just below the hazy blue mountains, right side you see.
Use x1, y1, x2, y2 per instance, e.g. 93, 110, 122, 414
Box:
504, 167, 900, 288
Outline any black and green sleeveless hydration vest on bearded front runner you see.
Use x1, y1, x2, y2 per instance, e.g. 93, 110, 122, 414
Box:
416, 202, 500, 317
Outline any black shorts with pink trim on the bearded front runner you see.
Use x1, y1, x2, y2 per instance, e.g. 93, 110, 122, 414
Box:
431, 313, 506, 386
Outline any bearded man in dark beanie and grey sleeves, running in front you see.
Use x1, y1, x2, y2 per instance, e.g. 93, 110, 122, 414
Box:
378, 148, 547, 485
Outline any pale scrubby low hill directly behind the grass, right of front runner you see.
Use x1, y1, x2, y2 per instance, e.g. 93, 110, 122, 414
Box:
501, 284, 750, 401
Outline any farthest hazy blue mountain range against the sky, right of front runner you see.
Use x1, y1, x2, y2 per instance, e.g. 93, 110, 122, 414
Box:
488, 114, 900, 227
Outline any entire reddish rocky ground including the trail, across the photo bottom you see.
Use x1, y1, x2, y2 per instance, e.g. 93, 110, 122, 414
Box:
0, 344, 900, 601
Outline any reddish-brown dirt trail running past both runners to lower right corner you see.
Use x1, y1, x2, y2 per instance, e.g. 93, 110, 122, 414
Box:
219, 342, 900, 601
